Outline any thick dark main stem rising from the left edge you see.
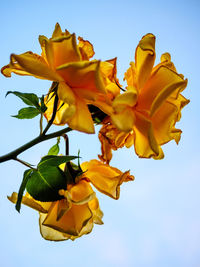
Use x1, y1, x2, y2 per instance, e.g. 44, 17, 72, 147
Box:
0, 127, 72, 163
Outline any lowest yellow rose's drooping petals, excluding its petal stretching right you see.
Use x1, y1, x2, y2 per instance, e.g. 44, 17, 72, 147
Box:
8, 180, 103, 241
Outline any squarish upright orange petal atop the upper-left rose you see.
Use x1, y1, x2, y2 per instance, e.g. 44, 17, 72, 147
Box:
50, 34, 81, 67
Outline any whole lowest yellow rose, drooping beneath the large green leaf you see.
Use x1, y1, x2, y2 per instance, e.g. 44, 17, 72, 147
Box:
8, 160, 134, 241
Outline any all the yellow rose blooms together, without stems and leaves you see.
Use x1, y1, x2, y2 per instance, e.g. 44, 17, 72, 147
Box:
1, 24, 189, 241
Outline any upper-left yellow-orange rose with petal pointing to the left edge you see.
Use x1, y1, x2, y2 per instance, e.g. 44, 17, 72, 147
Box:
1, 24, 105, 133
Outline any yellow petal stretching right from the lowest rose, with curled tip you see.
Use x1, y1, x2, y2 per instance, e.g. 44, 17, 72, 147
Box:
81, 160, 134, 199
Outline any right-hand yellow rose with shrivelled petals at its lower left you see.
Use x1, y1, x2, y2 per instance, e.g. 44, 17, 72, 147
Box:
100, 34, 189, 159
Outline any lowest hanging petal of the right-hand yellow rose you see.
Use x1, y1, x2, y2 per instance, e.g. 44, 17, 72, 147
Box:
133, 112, 159, 158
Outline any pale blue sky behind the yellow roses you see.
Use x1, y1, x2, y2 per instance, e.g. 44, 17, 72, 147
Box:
0, 0, 200, 267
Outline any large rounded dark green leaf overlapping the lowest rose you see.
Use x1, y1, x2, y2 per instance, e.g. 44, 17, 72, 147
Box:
26, 169, 67, 202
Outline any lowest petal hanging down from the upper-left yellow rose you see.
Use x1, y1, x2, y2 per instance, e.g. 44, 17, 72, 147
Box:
68, 96, 94, 133
